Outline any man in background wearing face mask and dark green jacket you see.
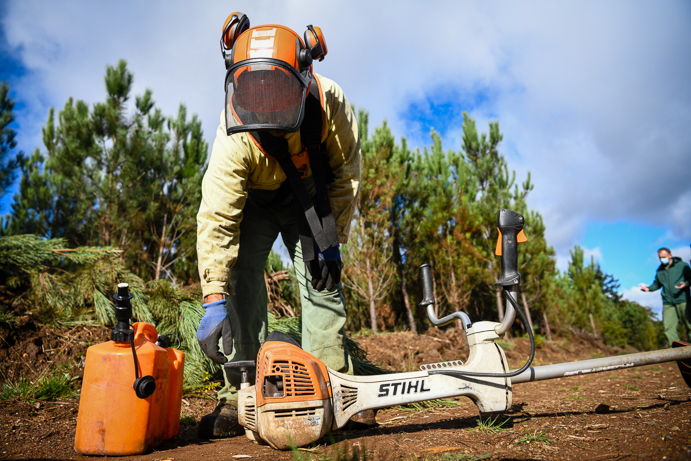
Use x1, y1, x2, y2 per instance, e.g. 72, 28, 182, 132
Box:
641, 248, 691, 346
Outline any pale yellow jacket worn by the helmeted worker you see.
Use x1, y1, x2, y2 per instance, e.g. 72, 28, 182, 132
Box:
197, 75, 360, 296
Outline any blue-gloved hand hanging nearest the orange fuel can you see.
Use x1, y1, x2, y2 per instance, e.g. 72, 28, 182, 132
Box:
197, 299, 233, 364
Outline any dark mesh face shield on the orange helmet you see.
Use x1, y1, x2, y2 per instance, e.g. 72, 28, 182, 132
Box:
225, 58, 311, 135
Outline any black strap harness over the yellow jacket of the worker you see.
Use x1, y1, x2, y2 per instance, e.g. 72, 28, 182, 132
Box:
250, 78, 338, 262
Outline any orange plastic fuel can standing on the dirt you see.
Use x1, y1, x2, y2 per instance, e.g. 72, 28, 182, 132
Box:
74, 322, 185, 456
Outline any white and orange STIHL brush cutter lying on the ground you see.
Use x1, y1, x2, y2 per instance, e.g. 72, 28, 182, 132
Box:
225, 209, 691, 450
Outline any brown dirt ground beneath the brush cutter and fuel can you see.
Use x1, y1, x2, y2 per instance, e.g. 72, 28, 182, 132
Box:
0, 321, 691, 461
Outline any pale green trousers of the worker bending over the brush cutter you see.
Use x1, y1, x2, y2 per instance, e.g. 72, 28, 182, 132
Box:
218, 191, 353, 404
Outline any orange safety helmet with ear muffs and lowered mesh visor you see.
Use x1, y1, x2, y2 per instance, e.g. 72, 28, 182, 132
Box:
221, 12, 327, 135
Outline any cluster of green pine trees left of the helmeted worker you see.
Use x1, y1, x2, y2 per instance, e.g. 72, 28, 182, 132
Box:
6, 60, 208, 282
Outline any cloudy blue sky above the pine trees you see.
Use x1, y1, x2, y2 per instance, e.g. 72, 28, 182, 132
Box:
0, 0, 691, 318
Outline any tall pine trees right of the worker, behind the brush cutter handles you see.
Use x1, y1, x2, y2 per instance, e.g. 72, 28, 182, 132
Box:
344, 111, 554, 331
